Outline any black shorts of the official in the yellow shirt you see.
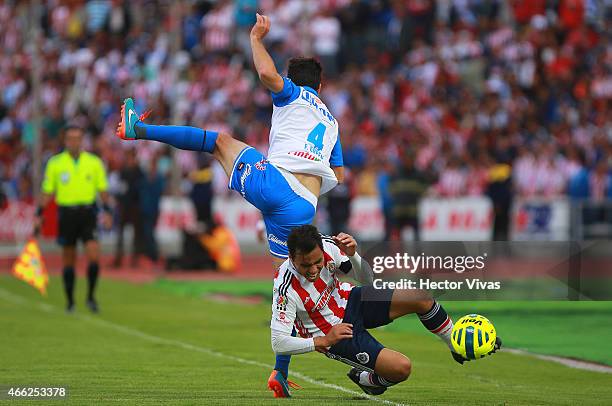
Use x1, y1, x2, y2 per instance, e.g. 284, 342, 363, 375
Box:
57, 206, 98, 246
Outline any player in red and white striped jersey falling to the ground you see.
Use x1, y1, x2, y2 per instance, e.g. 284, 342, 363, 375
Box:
270, 225, 501, 395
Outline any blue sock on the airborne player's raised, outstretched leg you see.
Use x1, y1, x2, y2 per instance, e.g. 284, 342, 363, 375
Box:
134, 122, 219, 154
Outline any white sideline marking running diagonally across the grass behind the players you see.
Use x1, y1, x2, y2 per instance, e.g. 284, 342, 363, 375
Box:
0, 288, 404, 406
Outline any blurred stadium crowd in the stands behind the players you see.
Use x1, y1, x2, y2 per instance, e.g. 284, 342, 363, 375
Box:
0, 0, 612, 233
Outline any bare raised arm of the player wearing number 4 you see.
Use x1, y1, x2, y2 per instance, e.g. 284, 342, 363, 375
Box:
251, 14, 284, 93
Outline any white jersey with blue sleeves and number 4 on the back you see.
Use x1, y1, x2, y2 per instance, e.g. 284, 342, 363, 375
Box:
268, 78, 343, 194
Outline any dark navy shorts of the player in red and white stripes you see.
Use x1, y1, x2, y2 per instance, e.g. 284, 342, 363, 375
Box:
325, 286, 393, 371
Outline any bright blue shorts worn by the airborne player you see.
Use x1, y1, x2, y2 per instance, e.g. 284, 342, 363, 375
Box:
229, 147, 316, 258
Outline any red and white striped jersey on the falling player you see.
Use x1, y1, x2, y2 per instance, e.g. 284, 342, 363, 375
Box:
270, 237, 353, 338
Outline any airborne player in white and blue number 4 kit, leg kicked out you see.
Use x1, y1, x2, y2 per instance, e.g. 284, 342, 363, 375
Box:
117, 14, 344, 397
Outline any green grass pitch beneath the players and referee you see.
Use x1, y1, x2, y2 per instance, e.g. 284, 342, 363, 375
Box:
0, 275, 612, 405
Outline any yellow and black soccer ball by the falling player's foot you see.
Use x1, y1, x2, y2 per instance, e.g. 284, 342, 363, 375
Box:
451, 314, 497, 359
